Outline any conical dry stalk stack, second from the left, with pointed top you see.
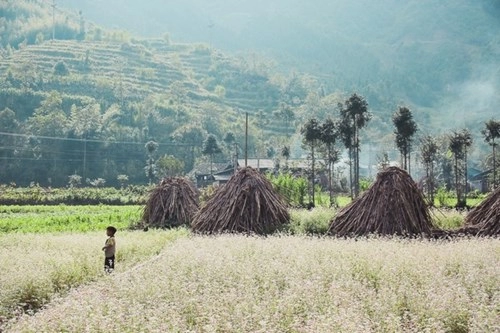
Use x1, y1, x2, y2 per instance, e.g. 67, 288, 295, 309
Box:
192, 167, 290, 235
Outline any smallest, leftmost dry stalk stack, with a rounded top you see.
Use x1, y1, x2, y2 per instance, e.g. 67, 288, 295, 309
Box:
142, 177, 199, 228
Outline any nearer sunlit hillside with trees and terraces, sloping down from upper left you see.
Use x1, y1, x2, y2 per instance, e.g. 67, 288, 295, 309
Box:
0, 1, 304, 185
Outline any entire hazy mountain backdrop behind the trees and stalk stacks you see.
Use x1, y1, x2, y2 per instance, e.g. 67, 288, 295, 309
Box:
0, 0, 500, 186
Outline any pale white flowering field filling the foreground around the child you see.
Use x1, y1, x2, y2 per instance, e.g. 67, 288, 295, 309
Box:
0, 230, 500, 332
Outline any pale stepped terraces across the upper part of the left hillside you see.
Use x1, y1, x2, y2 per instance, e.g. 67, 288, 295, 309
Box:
0, 40, 279, 116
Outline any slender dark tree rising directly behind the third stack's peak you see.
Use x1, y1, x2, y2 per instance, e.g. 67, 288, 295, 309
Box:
392, 106, 418, 172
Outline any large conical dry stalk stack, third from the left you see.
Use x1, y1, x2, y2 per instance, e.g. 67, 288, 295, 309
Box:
328, 167, 434, 236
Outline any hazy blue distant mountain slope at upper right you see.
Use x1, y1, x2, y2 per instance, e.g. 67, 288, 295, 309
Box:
61, 0, 500, 116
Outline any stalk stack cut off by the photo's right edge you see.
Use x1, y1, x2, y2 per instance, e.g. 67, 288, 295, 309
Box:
463, 187, 500, 236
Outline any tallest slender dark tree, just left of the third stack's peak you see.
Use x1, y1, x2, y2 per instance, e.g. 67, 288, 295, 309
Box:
339, 93, 371, 197
